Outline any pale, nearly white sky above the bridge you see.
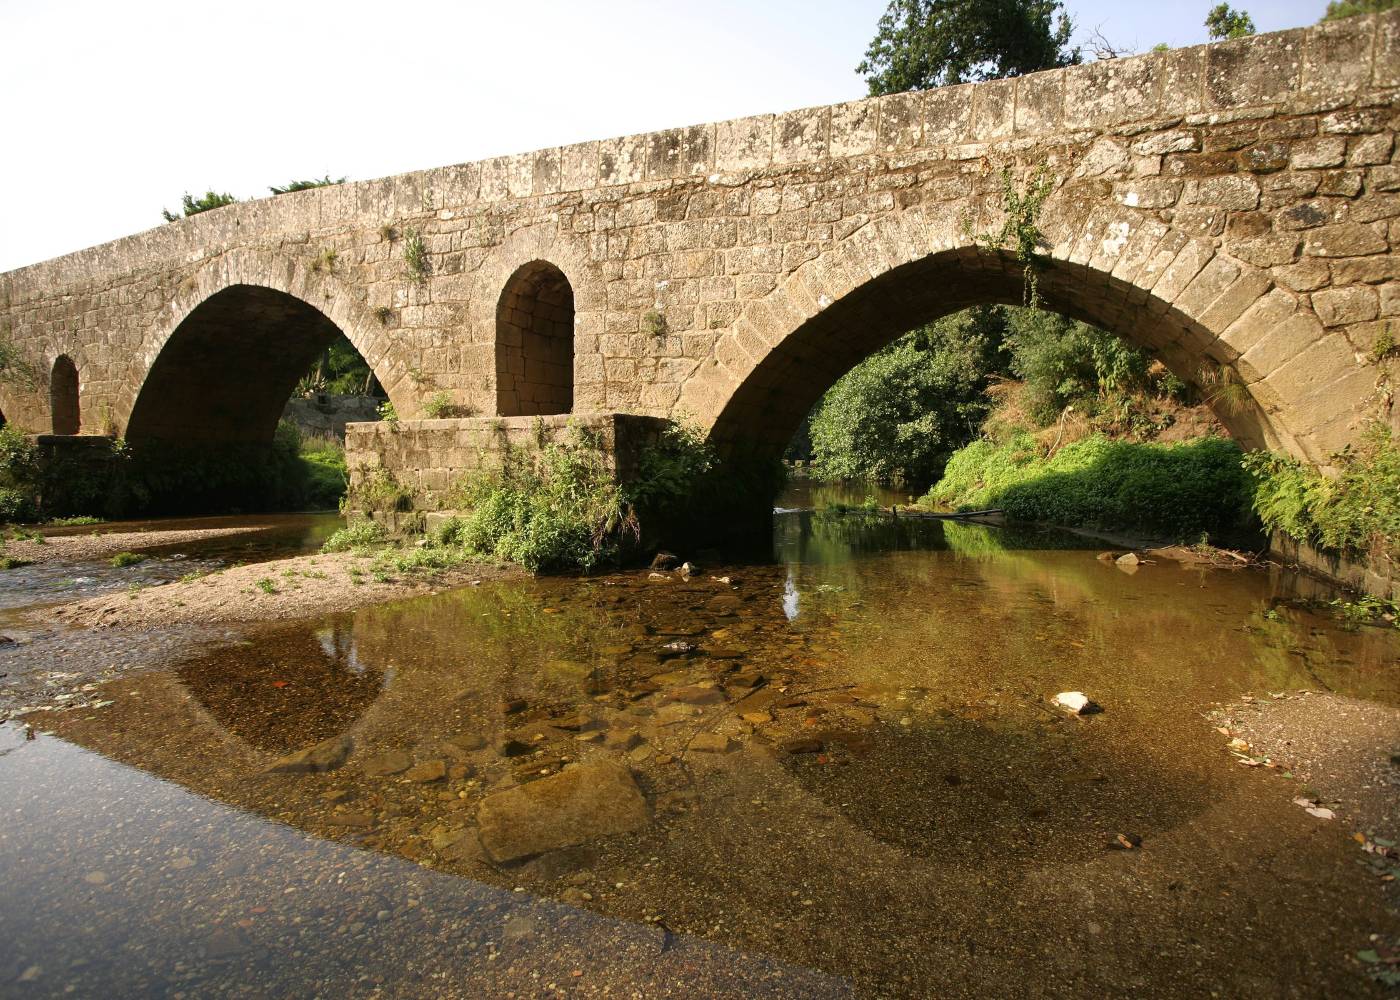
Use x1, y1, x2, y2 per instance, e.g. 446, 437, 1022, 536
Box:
0, 0, 1326, 272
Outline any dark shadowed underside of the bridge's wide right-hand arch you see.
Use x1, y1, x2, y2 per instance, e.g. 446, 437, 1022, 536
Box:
711, 246, 1273, 458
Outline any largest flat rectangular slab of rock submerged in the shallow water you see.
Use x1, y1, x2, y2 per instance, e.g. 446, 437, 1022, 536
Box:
476, 759, 651, 863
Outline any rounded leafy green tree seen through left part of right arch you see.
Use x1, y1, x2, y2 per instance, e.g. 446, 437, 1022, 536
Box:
811, 307, 1005, 487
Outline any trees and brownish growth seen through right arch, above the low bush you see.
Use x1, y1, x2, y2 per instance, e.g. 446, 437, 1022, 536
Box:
801, 307, 1212, 489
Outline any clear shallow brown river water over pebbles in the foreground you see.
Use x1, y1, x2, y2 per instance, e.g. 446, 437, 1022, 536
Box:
0, 486, 1400, 997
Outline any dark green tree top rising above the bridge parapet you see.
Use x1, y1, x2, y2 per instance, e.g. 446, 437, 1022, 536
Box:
855, 0, 1079, 97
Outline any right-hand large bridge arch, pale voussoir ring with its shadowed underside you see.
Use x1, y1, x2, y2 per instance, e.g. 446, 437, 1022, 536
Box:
676, 199, 1368, 462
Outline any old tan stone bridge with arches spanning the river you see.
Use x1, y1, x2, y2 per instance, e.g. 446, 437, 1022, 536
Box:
0, 14, 1400, 490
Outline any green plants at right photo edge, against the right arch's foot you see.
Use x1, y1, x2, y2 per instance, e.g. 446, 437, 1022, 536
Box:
1245, 423, 1400, 563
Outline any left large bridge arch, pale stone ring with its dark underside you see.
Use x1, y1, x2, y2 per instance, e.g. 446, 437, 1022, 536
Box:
116, 251, 408, 441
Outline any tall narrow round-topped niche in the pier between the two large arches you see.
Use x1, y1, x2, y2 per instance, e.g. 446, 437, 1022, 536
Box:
496, 261, 574, 416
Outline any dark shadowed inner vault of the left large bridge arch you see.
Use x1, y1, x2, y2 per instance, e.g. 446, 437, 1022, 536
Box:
126, 284, 375, 444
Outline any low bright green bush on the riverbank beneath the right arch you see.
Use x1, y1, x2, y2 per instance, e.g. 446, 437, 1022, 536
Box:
924, 431, 1252, 541
